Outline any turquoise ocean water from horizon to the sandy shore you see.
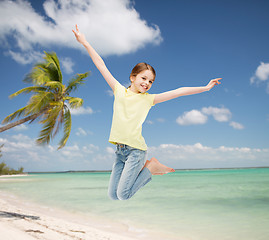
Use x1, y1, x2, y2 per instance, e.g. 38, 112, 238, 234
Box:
0, 168, 269, 240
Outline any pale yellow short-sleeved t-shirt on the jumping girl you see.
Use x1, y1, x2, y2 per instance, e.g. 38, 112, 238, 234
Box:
109, 82, 155, 150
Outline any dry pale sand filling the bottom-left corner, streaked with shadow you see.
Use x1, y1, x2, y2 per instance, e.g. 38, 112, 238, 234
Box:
0, 194, 141, 240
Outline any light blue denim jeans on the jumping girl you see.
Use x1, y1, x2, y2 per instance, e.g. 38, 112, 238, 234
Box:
108, 144, 152, 200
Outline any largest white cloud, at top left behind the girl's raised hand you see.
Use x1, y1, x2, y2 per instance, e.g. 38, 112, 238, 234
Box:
0, 0, 162, 64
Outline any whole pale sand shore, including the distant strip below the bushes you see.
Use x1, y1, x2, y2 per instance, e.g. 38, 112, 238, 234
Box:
0, 174, 171, 240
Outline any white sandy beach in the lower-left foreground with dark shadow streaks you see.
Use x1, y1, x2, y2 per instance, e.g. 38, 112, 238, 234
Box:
0, 186, 137, 240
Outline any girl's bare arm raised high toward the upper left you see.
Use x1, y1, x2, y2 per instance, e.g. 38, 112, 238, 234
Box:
72, 25, 117, 91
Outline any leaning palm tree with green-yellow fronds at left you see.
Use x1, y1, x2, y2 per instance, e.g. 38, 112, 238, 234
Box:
0, 52, 89, 149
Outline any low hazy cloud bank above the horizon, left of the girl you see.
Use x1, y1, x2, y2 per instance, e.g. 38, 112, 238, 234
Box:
0, 134, 114, 171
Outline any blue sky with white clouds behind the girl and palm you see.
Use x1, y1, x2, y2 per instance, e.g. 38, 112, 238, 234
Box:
0, 0, 269, 171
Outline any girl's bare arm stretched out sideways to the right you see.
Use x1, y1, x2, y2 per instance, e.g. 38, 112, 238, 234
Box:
154, 78, 221, 104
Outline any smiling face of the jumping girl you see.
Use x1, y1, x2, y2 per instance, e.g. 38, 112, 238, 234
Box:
130, 70, 154, 93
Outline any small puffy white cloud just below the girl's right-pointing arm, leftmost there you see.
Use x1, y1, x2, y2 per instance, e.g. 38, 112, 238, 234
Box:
176, 109, 207, 125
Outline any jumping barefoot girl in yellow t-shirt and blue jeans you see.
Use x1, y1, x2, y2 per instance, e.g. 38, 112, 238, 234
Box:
73, 25, 221, 200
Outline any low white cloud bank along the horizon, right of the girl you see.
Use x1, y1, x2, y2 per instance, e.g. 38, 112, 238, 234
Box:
148, 143, 269, 168
